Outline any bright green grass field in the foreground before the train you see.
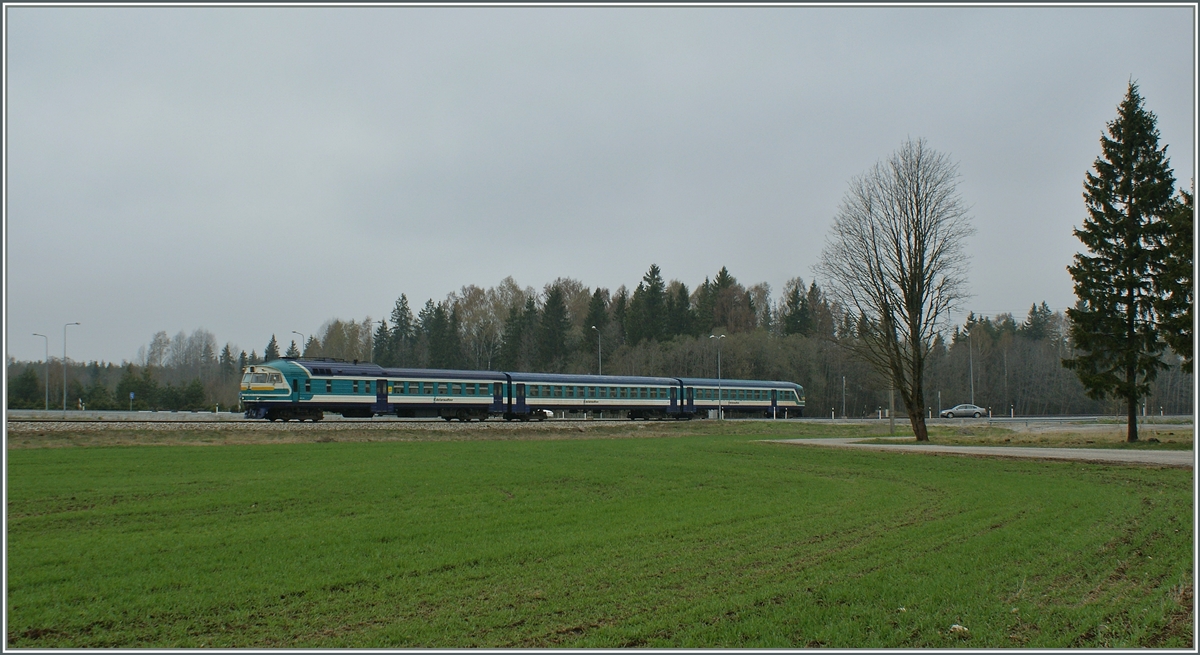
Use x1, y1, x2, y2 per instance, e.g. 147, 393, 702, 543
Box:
7, 428, 1194, 648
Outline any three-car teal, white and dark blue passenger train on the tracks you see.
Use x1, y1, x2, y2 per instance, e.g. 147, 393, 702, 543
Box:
239, 357, 804, 421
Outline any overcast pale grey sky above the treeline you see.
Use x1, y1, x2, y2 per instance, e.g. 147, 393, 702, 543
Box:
5, 5, 1196, 362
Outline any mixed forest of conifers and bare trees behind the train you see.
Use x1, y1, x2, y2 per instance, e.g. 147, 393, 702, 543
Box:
8, 266, 1193, 417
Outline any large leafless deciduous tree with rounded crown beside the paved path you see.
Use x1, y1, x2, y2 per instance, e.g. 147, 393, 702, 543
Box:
816, 139, 972, 440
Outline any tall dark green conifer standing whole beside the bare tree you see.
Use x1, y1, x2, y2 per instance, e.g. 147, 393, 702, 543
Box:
1063, 82, 1175, 441
